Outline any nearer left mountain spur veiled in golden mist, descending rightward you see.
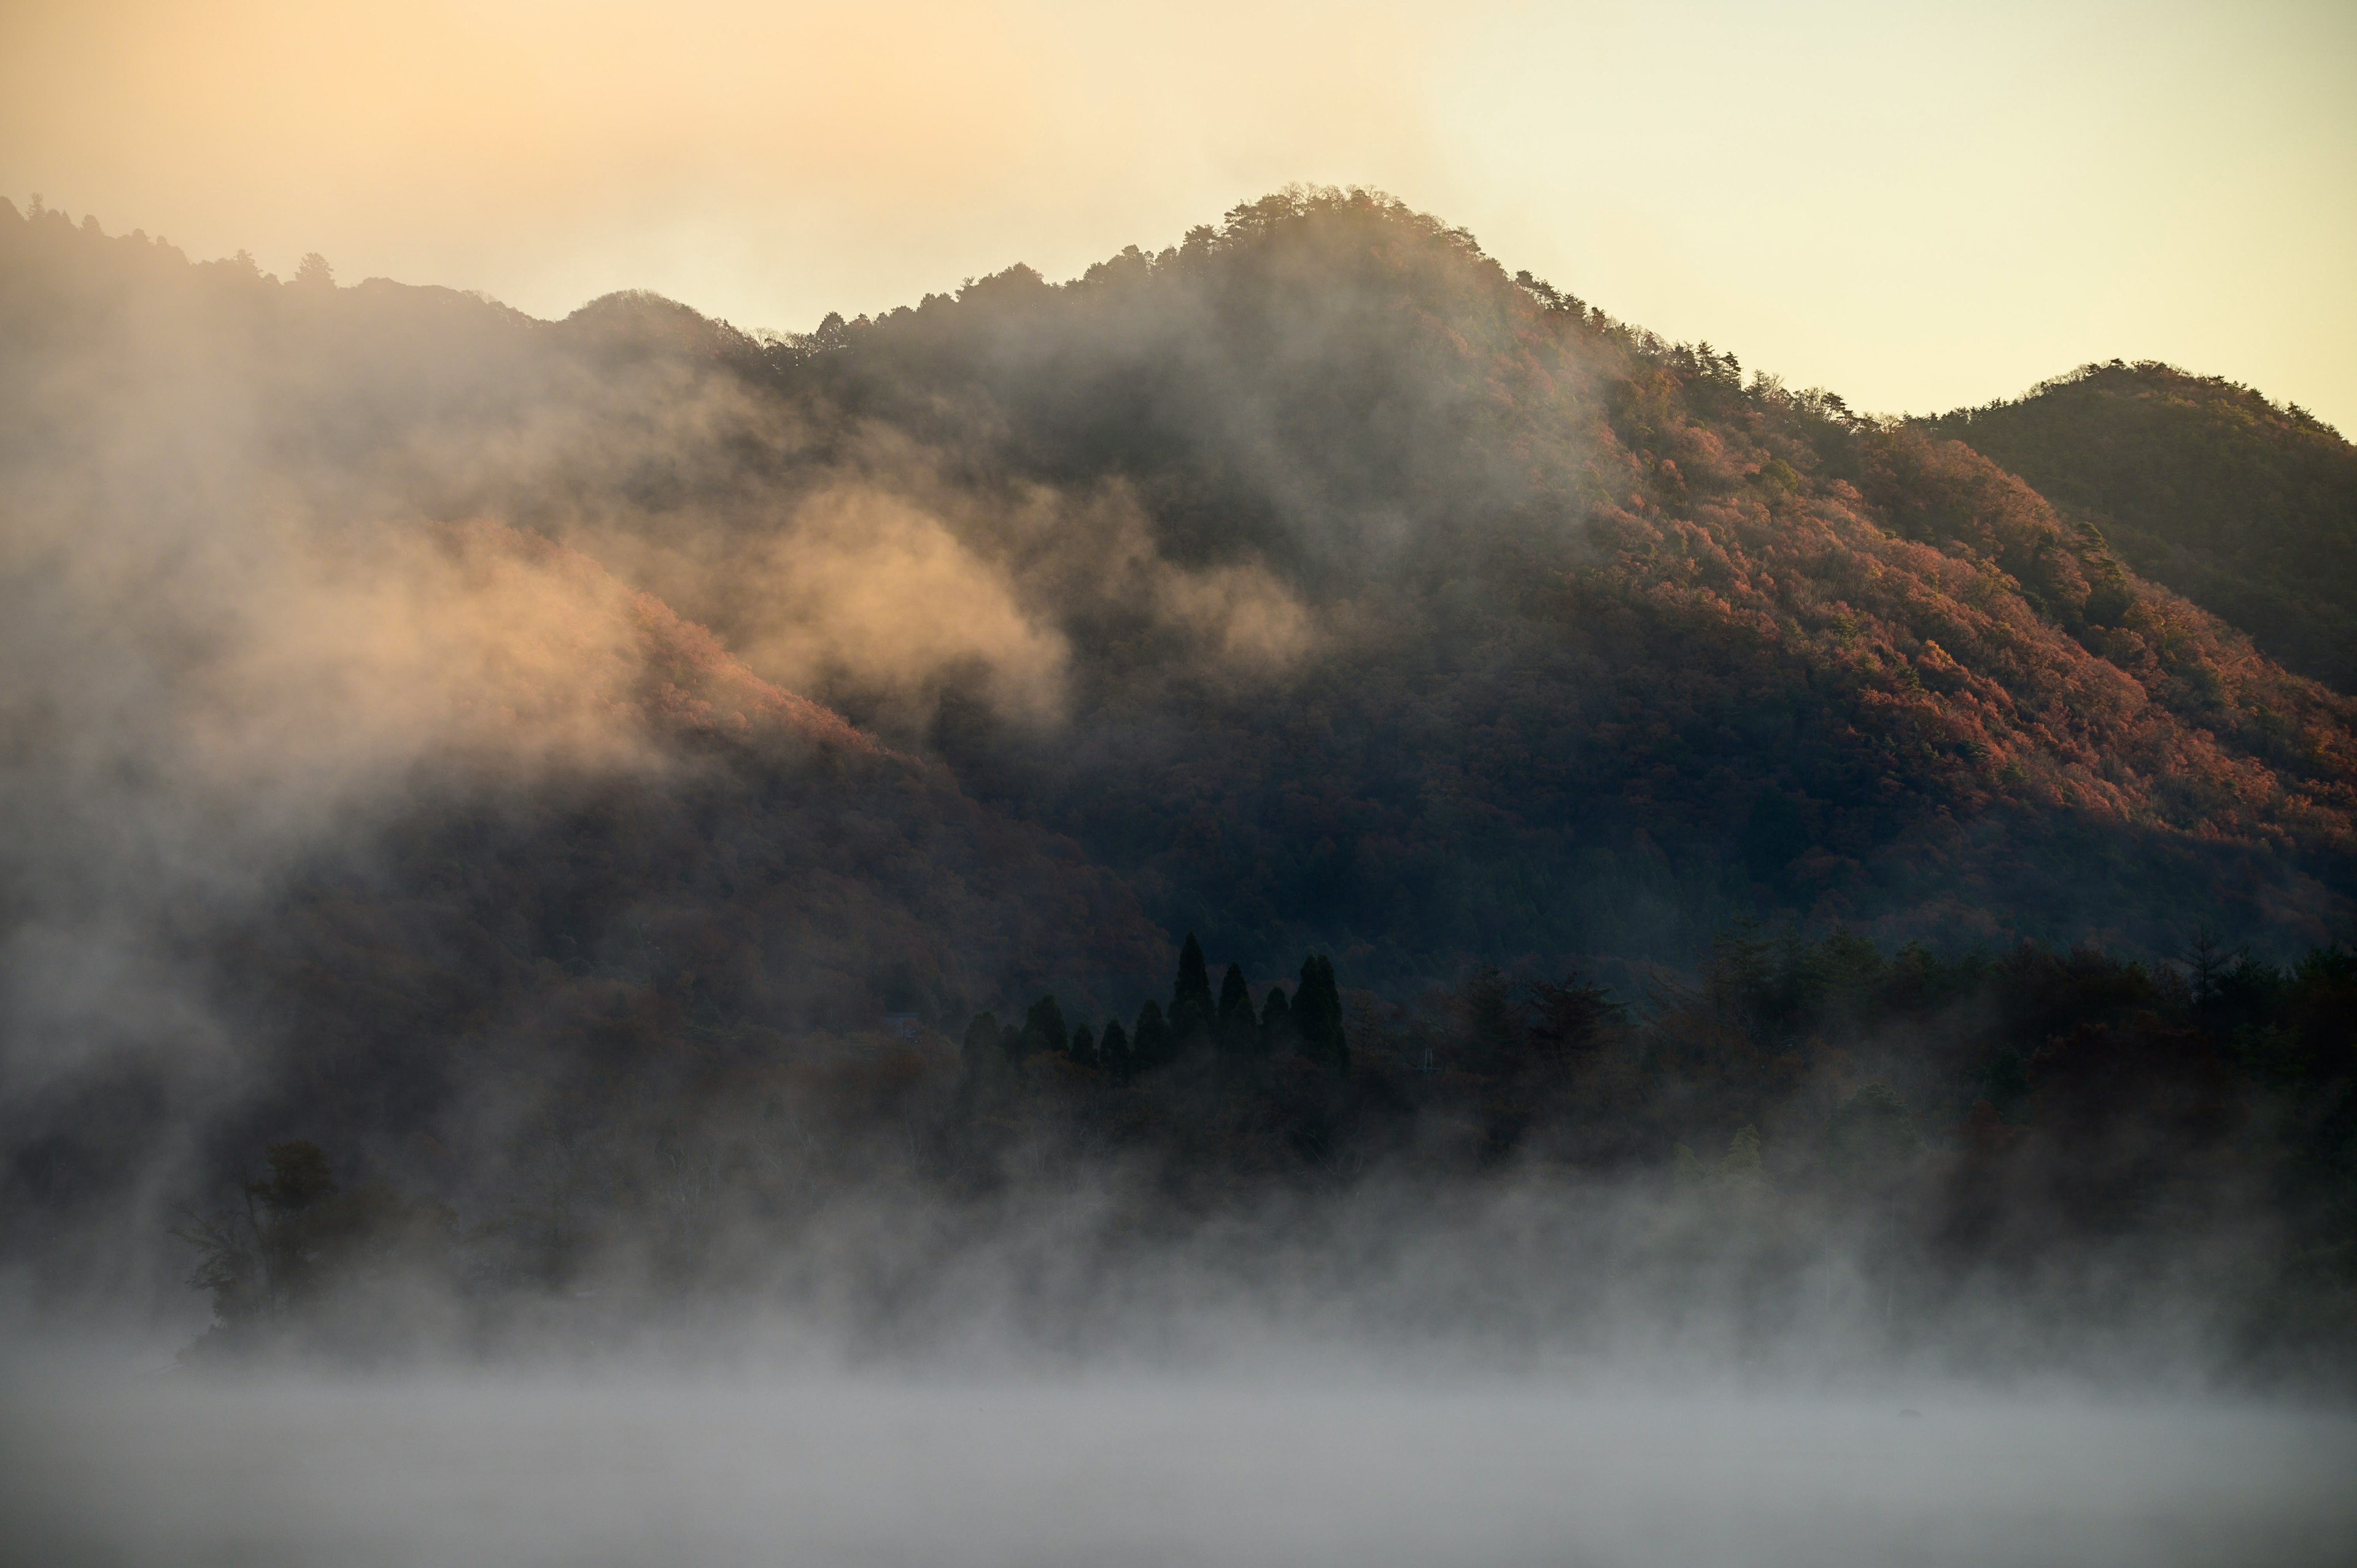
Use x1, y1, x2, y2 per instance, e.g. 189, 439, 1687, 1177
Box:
0, 215, 1162, 1252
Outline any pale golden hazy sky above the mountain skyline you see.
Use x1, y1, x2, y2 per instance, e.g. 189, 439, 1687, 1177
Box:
14, 0, 2357, 434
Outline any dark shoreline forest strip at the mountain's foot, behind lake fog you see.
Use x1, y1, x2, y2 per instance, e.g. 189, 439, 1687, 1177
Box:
174, 927, 2357, 1380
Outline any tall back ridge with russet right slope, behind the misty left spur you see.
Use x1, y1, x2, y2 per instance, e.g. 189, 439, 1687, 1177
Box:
7, 193, 2357, 990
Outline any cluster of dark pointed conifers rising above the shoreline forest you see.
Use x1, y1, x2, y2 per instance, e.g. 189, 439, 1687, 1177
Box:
964, 932, 1350, 1083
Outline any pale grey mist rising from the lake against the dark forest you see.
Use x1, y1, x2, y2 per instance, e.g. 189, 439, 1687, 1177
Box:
0, 1139, 2357, 1568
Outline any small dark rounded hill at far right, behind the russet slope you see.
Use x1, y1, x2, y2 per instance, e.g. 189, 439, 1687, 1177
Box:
1921, 361, 2357, 691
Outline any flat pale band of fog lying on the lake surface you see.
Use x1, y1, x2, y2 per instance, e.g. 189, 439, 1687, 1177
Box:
0, 1356, 2357, 1568
